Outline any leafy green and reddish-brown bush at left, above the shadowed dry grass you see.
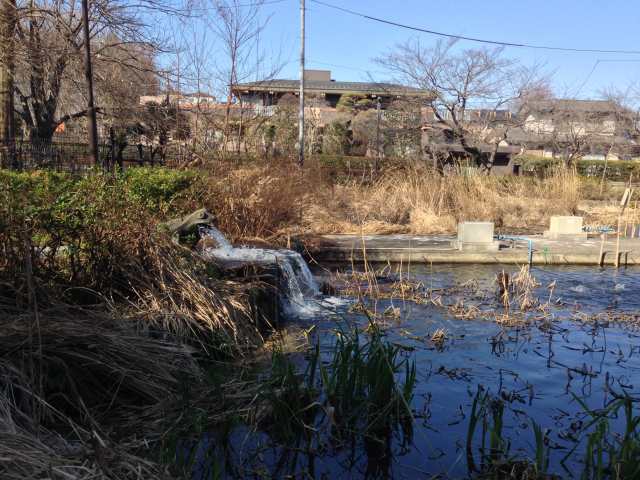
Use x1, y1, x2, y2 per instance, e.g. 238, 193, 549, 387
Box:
0, 171, 154, 293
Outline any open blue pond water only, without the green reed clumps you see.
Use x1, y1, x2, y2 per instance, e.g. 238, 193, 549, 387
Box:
192, 265, 640, 478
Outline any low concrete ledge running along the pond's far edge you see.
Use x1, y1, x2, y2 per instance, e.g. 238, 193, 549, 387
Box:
299, 235, 640, 266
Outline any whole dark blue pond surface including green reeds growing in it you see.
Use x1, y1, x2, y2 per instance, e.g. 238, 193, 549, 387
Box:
185, 265, 640, 479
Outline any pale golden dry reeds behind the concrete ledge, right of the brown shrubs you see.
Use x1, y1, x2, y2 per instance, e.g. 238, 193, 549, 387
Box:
302, 167, 581, 234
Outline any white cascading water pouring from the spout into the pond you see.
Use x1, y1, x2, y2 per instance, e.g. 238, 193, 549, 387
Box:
200, 227, 330, 315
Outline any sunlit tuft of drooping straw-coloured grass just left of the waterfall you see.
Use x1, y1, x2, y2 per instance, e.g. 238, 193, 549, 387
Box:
130, 240, 268, 354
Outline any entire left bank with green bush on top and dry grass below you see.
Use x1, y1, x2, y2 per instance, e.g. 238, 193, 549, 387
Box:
0, 170, 272, 479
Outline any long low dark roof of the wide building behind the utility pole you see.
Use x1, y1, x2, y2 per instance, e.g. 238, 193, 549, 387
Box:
233, 79, 429, 96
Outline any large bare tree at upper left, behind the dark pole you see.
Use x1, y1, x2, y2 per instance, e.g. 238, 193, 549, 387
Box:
15, 0, 169, 140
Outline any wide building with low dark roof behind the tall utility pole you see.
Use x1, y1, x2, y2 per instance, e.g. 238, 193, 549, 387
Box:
232, 70, 430, 108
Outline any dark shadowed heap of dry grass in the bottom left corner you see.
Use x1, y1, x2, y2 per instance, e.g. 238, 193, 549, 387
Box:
0, 314, 189, 480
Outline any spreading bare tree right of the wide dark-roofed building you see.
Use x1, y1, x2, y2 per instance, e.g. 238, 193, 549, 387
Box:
377, 40, 546, 172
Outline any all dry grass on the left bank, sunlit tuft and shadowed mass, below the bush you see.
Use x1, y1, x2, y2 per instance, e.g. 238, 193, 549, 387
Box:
0, 237, 272, 479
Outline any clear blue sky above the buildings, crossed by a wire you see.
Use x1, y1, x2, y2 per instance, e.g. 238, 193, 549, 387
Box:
247, 0, 640, 98
